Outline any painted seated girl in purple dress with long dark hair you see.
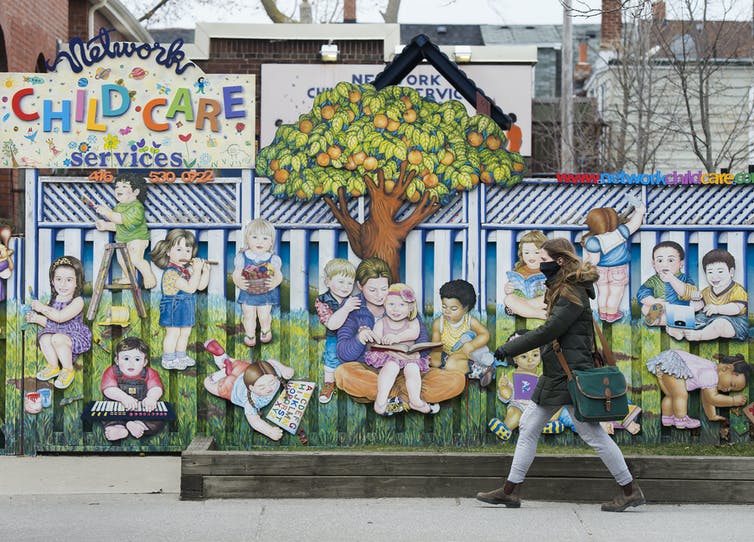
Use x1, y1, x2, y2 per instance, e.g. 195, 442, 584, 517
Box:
26, 256, 92, 389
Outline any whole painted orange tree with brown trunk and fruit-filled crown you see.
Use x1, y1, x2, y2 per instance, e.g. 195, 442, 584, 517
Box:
256, 82, 524, 280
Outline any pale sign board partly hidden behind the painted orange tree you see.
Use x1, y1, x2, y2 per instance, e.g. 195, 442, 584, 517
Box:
260, 64, 533, 156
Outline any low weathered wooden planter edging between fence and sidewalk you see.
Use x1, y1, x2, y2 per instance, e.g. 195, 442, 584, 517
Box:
181, 436, 754, 504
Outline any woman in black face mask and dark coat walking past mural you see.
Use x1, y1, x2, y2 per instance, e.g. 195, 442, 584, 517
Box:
476, 238, 646, 512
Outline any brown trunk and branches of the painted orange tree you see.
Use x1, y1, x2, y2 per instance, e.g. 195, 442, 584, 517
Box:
324, 160, 440, 282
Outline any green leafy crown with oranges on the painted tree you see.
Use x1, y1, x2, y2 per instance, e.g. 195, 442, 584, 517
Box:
256, 82, 524, 203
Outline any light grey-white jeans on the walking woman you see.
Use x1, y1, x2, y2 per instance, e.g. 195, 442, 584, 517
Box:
508, 403, 633, 486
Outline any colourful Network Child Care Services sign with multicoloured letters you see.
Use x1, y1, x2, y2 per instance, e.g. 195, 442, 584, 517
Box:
0, 29, 255, 169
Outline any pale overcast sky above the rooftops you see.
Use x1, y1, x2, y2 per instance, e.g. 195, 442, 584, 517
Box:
121, 0, 752, 28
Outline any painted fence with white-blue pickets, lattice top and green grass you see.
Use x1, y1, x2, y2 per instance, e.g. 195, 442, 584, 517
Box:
0, 172, 754, 454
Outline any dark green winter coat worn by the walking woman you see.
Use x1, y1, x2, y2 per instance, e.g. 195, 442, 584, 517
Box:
502, 282, 594, 406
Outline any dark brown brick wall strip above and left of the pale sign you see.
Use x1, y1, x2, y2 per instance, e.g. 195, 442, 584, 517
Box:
197, 39, 384, 134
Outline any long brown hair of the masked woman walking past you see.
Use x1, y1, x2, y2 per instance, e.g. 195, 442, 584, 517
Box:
541, 237, 599, 313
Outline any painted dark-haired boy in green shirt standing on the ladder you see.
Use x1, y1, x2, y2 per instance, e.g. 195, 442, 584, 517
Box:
94, 173, 157, 289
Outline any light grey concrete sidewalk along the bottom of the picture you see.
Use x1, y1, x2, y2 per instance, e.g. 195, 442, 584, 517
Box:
0, 455, 754, 542
